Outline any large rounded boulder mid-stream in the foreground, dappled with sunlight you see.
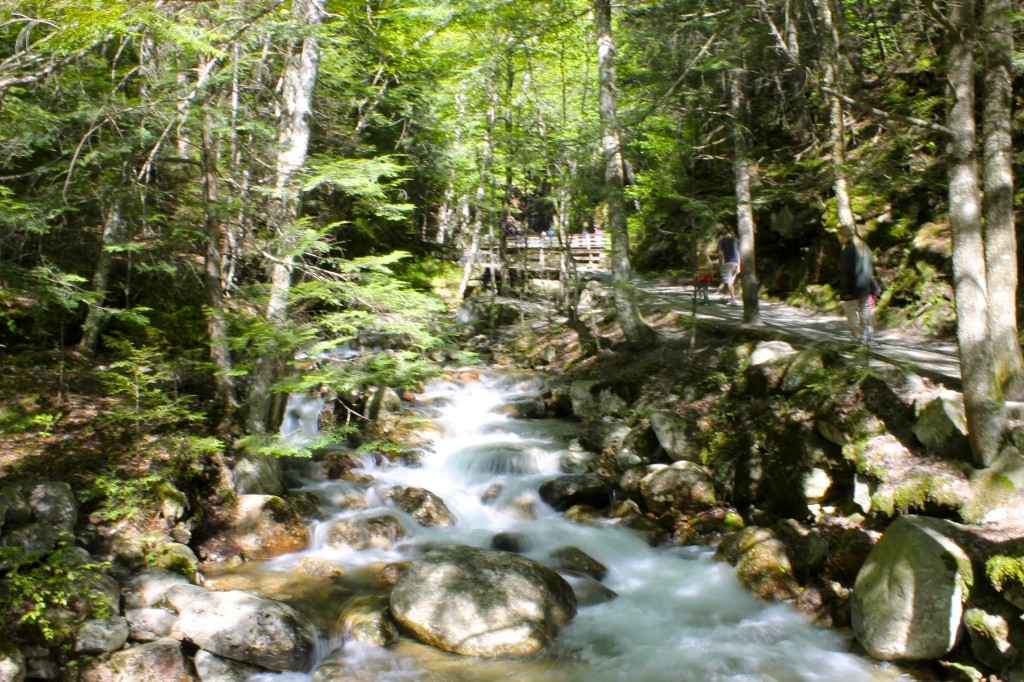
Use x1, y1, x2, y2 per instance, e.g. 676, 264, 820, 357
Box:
390, 546, 577, 656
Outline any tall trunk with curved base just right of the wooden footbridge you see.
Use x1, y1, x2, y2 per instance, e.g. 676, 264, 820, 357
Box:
594, 0, 655, 347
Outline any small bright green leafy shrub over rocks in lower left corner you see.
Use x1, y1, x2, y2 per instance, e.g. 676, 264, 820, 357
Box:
0, 537, 111, 642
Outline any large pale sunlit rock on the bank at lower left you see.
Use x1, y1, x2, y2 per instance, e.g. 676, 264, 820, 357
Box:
168, 588, 316, 672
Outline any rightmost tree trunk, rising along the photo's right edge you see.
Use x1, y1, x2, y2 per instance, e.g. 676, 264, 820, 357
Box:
982, 0, 1024, 400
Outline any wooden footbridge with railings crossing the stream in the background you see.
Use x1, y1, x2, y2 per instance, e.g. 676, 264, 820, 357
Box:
473, 233, 608, 280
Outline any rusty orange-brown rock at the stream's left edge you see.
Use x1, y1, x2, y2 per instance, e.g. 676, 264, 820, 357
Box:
227, 495, 309, 560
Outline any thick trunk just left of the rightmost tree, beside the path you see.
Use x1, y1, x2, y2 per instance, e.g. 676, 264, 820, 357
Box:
946, 0, 1004, 467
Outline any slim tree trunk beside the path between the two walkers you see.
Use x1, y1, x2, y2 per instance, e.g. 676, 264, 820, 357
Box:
730, 68, 761, 325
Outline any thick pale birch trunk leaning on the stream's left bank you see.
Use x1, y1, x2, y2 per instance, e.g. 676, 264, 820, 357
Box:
246, 0, 326, 433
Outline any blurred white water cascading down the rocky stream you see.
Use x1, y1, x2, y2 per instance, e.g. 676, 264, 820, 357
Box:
253, 368, 905, 682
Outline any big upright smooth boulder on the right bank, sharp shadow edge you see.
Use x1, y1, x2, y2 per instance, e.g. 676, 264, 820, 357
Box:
851, 516, 974, 660
